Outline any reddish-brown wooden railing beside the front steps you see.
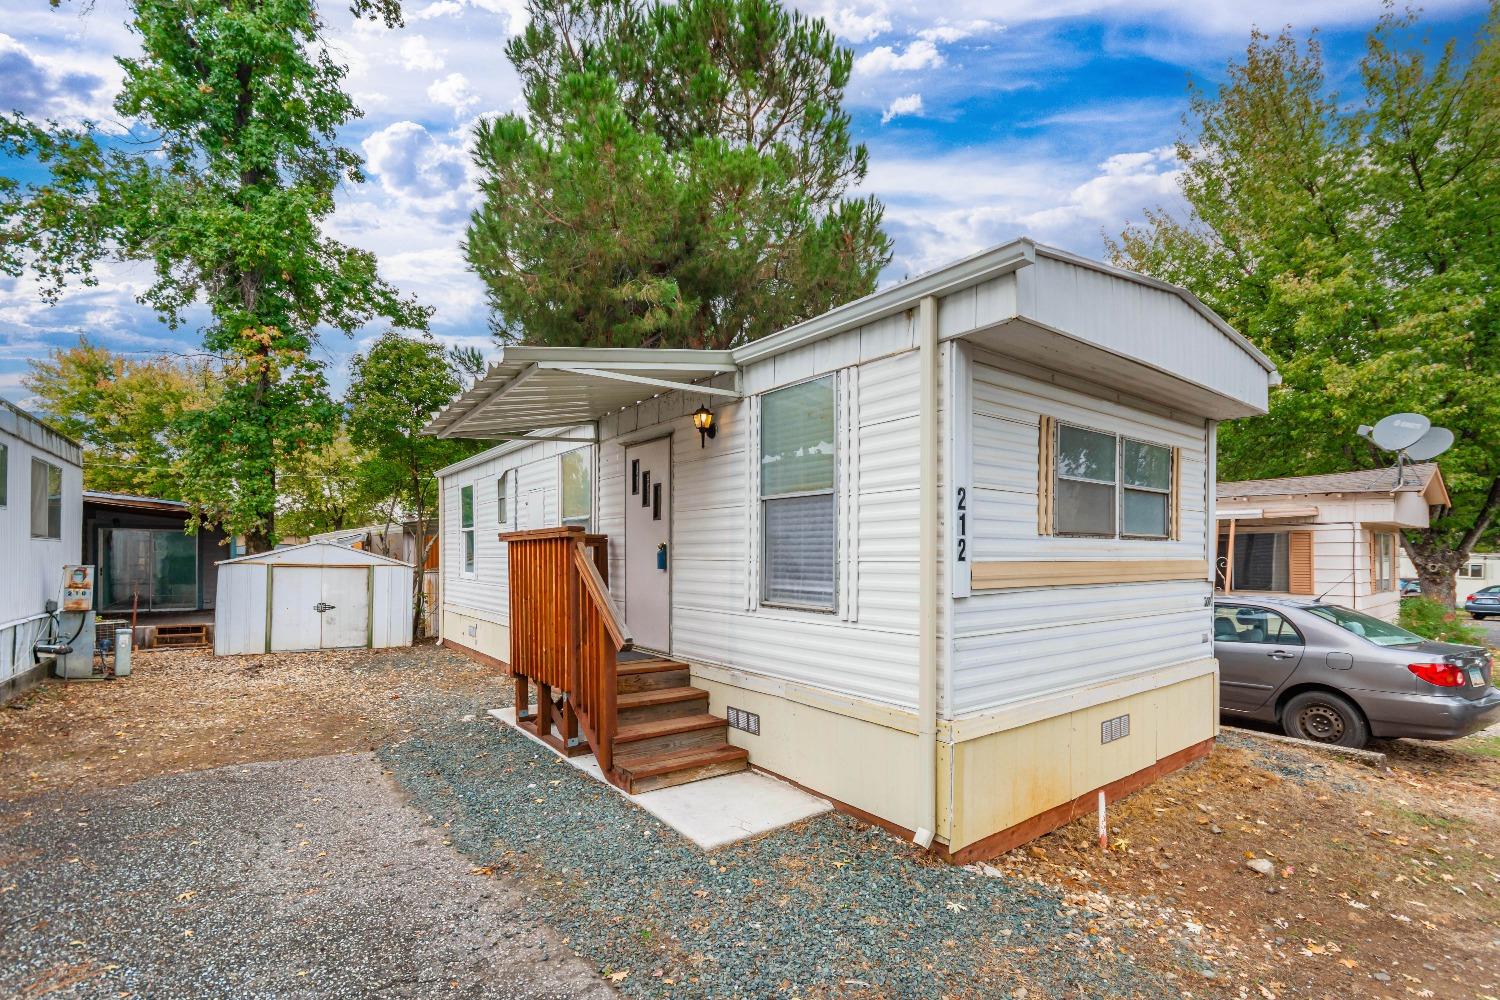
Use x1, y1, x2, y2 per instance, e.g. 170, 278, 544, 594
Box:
501, 528, 632, 775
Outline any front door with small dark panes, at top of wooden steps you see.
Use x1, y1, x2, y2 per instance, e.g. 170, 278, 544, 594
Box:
626, 438, 672, 652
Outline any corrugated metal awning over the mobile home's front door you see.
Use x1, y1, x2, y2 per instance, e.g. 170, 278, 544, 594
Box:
423, 346, 740, 441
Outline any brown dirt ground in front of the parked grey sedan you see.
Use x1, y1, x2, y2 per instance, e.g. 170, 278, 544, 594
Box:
995, 729, 1500, 1000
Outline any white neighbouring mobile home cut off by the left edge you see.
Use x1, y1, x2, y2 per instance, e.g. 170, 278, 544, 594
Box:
0, 399, 84, 700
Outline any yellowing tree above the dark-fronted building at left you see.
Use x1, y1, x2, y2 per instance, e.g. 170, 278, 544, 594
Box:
21, 337, 219, 499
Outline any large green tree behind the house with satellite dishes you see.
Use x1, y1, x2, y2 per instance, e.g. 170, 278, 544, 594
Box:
1112, 6, 1500, 603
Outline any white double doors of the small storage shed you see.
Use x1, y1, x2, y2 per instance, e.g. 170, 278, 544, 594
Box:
272, 567, 371, 652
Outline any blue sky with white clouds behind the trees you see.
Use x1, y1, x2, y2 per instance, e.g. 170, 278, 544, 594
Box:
0, 0, 1485, 403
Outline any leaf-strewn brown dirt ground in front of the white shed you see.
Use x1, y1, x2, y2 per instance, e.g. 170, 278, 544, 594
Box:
0, 643, 498, 802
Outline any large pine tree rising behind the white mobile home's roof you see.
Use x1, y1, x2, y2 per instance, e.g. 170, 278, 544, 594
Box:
465, 0, 891, 348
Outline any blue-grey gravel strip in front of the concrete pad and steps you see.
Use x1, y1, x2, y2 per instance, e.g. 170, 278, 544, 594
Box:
380, 711, 1182, 997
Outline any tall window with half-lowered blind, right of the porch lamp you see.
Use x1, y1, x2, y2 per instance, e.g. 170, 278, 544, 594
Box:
761, 375, 839, 612
